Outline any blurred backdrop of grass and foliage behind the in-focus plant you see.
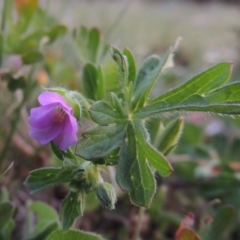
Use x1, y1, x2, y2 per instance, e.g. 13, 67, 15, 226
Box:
0, 0, 240, 240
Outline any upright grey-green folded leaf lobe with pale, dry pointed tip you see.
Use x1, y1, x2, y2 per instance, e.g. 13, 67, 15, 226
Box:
133, 49, 173, 108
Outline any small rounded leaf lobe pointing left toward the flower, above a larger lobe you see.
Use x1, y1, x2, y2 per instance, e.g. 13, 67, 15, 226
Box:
89, 101, 122, 126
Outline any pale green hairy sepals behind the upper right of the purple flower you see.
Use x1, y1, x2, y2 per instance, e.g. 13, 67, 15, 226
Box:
46, 87, 82, 121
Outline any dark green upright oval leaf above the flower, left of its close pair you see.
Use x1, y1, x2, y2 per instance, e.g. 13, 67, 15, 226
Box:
82, 63, 98, 100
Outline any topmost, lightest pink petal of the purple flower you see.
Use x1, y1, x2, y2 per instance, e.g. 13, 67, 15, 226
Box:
38, 92, 72, 112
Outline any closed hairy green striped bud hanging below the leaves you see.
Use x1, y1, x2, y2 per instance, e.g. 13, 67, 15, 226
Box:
94, 182, 117, 210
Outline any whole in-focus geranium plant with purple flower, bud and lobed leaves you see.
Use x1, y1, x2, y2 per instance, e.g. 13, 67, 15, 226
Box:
25, 37, 240, 239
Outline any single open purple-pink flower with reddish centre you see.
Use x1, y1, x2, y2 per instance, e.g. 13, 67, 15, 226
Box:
28, 92, 78, 151
